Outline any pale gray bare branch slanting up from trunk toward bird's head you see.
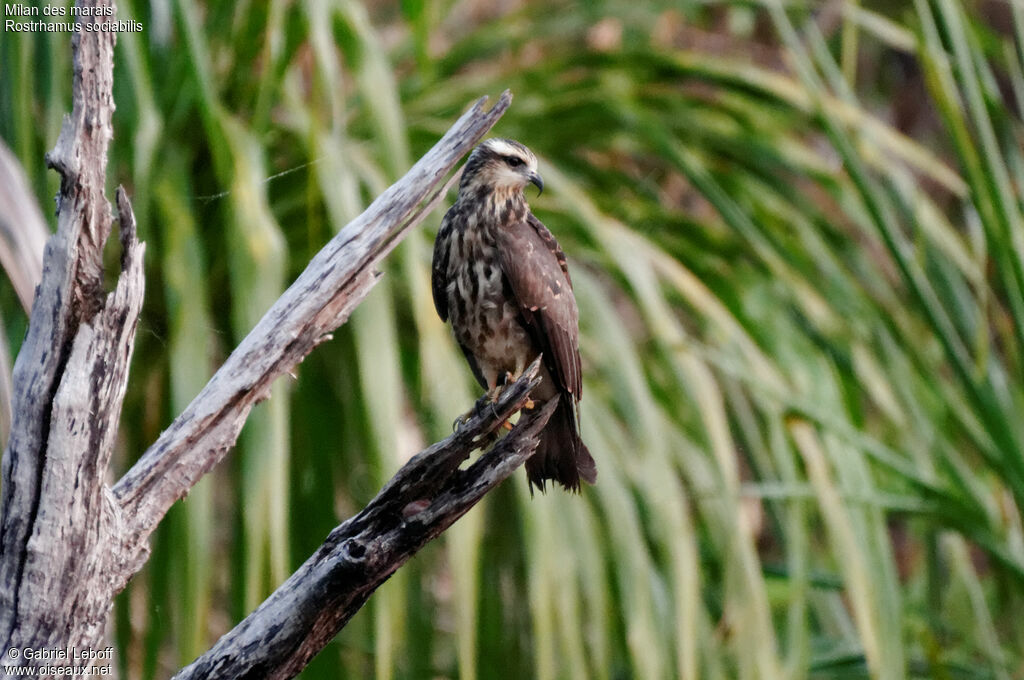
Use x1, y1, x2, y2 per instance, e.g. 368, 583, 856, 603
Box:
114, 87, 512, 585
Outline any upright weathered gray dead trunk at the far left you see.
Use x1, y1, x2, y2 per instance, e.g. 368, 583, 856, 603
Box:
0, 1, 132, 650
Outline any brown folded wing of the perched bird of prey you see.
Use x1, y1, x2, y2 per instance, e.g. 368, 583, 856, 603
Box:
498, 213, 583, 401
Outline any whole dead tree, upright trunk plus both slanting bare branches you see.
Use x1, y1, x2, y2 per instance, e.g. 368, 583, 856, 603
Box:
0, 0, 520, 677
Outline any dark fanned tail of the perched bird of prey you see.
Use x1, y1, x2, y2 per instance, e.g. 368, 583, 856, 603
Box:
526, 395, 597, 493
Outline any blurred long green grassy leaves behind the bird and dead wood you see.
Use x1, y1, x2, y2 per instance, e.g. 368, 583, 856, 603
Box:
0, 0, 1024, 680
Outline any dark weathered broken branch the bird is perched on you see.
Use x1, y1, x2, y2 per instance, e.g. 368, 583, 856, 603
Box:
175, 362, 556, 680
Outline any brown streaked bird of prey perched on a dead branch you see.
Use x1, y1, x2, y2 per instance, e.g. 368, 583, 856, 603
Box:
431, 139, 597, 492
